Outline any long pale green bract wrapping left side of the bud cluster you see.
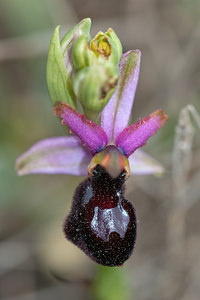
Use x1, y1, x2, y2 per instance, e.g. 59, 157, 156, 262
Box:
47, 18, 91, 108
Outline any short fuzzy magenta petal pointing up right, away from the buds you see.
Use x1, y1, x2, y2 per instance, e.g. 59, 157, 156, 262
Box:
115, 110, 168, 157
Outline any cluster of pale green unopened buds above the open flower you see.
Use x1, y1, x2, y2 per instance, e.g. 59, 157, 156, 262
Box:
47, 18, 122, 114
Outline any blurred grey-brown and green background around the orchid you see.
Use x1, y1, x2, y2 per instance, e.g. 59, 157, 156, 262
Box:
0, 0, 200, 300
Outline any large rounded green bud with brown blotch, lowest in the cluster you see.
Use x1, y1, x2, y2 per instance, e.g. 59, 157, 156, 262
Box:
73, 63, 119, 114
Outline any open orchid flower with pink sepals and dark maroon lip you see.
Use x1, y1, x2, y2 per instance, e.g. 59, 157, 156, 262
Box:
16, 20, 167, 266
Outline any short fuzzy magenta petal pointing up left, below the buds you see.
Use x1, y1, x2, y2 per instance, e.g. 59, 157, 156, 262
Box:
54, 102, 108, 154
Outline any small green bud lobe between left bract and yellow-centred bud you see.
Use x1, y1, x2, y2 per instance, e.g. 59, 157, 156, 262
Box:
72, 35, 97, 71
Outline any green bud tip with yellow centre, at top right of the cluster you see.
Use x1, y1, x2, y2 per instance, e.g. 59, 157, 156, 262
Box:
91, 28, 122, 65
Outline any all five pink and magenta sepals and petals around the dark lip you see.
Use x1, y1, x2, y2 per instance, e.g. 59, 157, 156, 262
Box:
16, 50, 167, 175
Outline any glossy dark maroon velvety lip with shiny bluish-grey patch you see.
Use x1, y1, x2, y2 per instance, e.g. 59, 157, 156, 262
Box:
64, 165, 137, 267
